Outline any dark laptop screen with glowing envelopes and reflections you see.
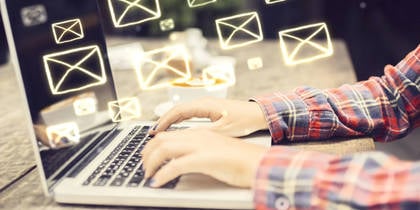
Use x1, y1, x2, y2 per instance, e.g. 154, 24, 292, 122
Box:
5, 0, 116, 189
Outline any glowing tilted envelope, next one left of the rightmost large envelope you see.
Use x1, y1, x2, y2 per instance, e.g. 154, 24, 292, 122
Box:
216, 12, 264, 49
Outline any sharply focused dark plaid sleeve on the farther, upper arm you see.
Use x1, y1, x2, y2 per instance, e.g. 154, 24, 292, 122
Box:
251, 45, 420, 144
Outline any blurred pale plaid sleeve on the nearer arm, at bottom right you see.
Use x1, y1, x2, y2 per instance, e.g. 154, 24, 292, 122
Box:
254, 146, 420, 210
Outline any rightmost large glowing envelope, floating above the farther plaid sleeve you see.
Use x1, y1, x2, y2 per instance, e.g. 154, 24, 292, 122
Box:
279, 23, 334, 65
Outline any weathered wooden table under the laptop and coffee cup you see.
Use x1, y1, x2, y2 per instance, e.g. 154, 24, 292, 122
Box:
0, 38, 374, 209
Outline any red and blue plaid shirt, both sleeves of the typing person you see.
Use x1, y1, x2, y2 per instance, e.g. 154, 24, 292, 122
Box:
253, 46, 420, 210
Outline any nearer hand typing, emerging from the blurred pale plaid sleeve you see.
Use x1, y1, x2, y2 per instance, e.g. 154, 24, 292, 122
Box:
142, 129, 268, 188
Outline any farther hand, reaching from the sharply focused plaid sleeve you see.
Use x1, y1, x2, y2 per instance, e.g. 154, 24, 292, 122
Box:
150, 98, 268, 137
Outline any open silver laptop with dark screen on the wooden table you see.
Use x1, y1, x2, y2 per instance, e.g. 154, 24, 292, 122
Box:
1, 0, 270, 209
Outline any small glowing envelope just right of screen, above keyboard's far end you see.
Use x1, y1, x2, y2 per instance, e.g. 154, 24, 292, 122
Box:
108, 98, 141, 122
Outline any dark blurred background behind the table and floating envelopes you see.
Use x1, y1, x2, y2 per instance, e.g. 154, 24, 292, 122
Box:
0, 0, 420, 159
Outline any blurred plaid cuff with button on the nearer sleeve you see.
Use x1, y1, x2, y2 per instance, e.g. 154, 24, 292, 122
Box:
254, 146, 331, 209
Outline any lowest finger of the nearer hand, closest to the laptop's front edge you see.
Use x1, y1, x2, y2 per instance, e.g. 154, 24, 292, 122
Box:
150, 155, 198, 188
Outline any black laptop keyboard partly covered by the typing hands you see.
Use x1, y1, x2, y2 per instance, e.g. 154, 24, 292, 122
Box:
83, 126, 179, 189
